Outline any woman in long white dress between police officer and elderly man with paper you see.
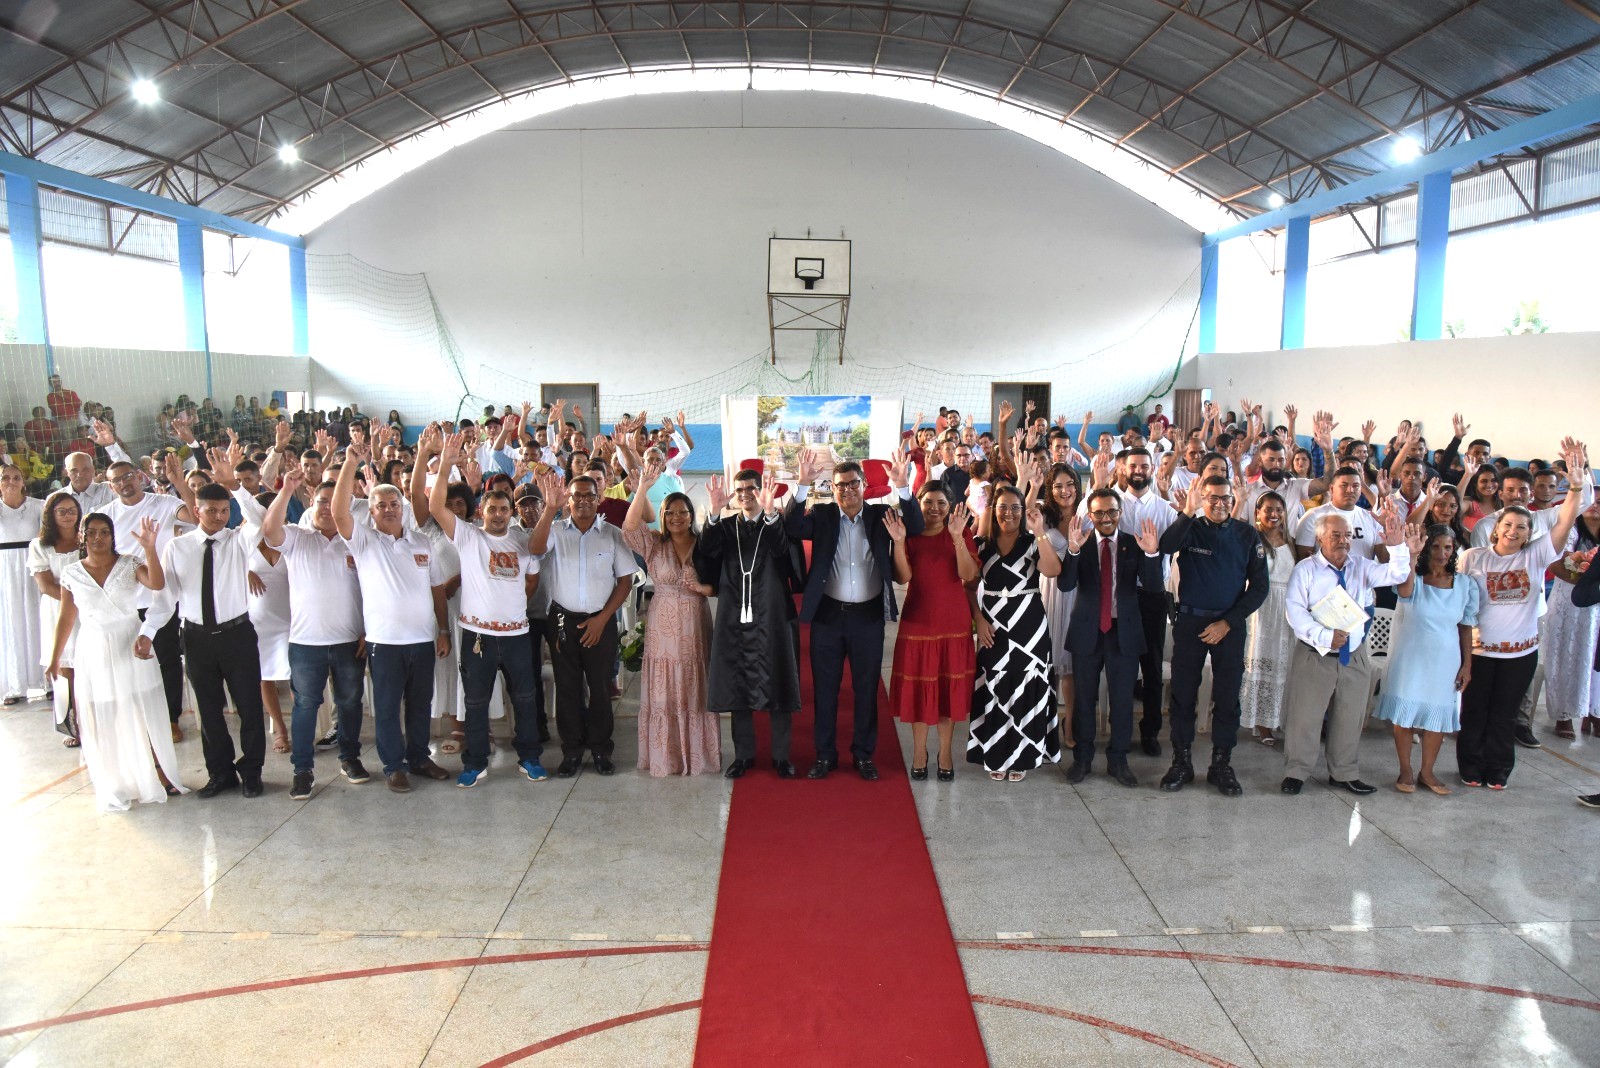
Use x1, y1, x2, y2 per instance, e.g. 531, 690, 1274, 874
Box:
1238, 489, 1294, 745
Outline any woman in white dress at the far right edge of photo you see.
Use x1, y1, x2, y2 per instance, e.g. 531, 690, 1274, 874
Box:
1539, 504, 1600, 739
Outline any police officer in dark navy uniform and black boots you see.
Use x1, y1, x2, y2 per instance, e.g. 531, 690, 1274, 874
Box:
1162, 475, 1270, 798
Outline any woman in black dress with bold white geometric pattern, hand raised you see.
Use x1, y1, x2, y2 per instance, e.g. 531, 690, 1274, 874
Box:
966, 486, 1061, 782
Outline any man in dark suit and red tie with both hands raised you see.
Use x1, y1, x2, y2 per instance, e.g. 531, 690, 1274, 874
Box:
1056, 489, 1162, 787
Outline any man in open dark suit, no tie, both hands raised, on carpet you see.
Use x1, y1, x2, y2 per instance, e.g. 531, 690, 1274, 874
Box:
784, 449, 922, 782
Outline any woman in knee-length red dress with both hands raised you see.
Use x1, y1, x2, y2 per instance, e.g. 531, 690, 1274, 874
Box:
883, 480, 978, 782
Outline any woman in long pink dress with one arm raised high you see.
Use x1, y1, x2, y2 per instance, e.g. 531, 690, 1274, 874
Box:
622, 460, 722, 775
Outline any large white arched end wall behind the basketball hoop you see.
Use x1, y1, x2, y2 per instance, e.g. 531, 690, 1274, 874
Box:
307, 91, 1198, 422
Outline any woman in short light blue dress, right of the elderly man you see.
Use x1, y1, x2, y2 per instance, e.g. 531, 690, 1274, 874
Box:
1373, 523, 1478, 793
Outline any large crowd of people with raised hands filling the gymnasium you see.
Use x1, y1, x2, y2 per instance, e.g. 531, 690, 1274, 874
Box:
0, 388, 1600, 809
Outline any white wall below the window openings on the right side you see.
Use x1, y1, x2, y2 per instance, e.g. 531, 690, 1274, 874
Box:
1179, 333, 1600, 460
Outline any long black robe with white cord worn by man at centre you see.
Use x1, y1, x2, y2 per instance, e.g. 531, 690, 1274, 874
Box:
694, 516, 800, 711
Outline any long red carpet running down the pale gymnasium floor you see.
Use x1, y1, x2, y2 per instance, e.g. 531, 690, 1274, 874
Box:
694, 628, 989, 1068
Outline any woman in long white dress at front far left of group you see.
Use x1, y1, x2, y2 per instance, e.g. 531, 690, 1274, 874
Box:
50, 512, 182, 812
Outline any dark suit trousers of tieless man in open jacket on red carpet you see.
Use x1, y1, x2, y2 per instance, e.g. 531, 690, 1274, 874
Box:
811, 596, 883, 764
